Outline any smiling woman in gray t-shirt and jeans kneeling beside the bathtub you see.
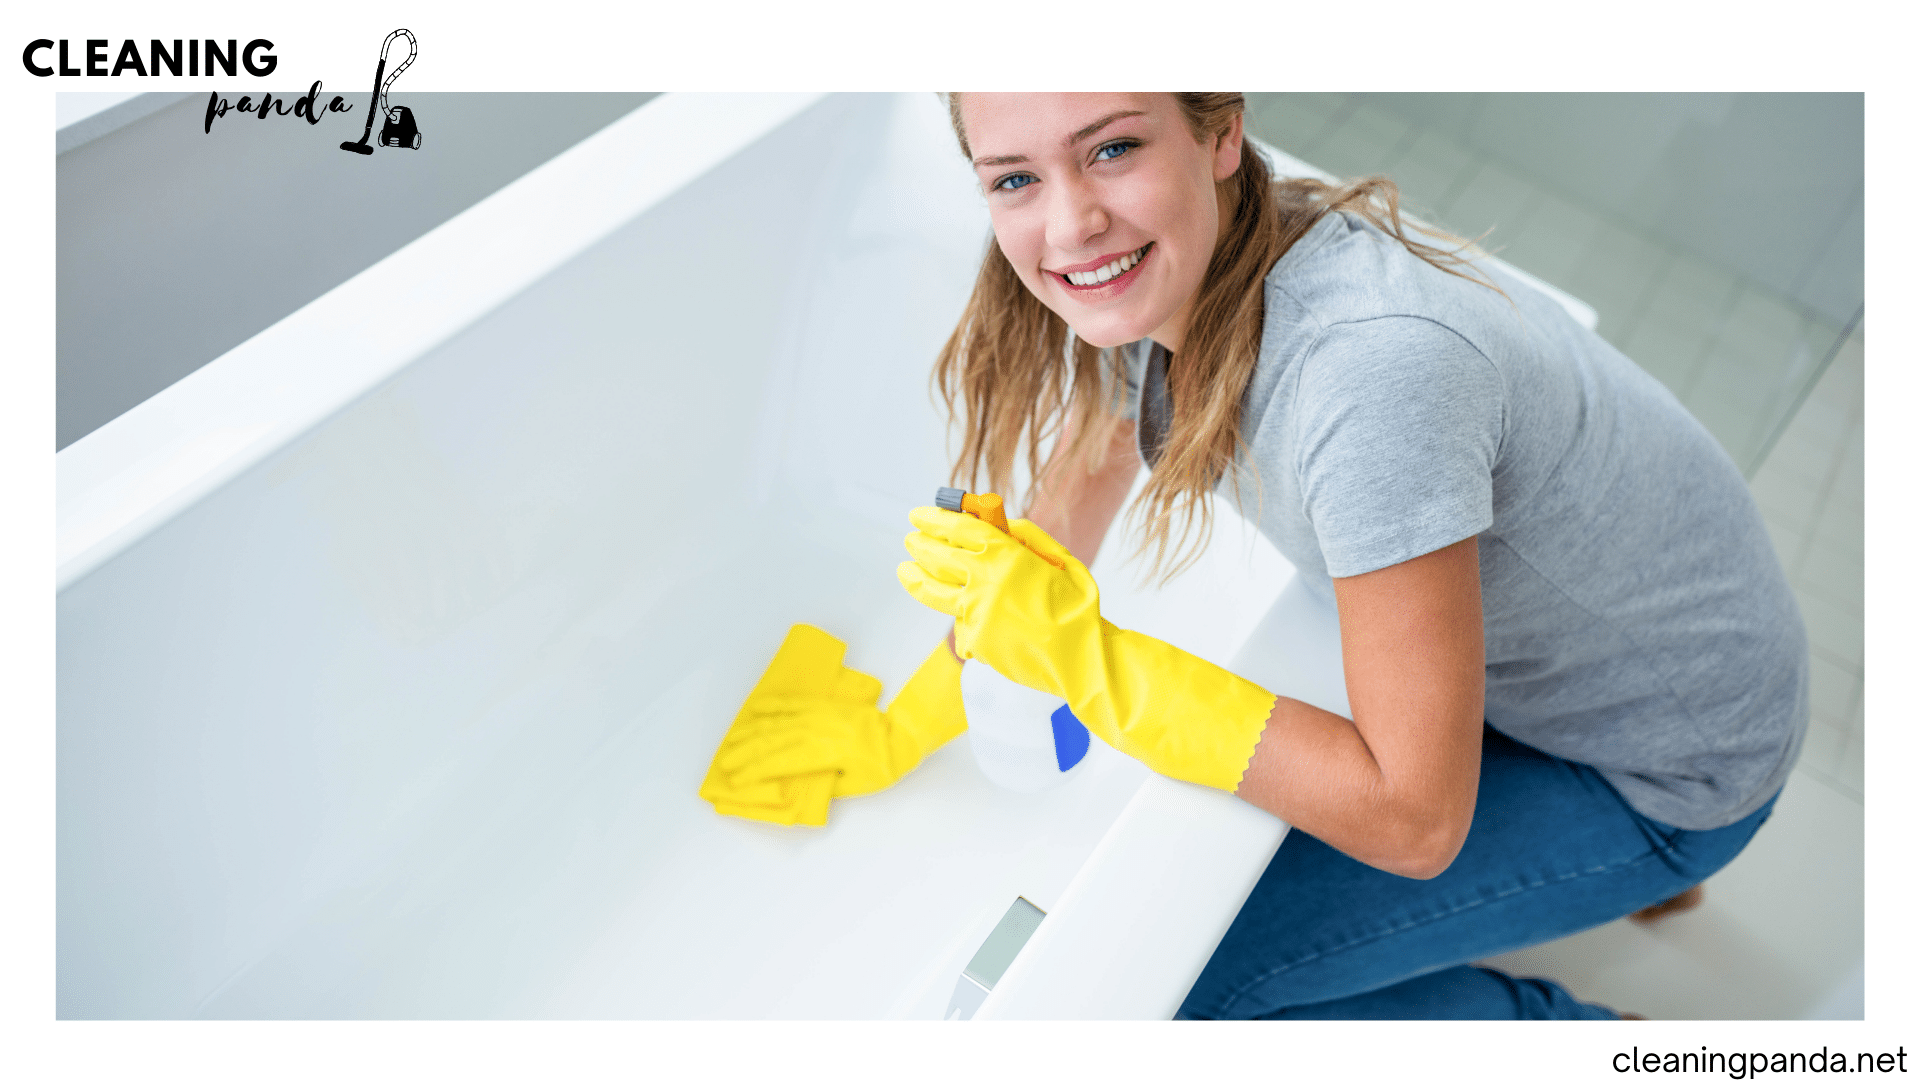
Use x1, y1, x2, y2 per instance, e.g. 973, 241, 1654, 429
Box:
900, 94, 1807, 1019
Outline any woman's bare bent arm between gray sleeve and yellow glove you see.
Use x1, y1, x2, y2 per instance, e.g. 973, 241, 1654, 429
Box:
1235, 538, 1486, 878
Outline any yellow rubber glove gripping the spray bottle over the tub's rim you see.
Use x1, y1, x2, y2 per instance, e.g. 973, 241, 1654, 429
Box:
899, 505, 1275, 792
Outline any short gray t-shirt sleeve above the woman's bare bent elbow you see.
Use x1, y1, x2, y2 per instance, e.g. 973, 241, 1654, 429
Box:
1294, 315, 1505, 578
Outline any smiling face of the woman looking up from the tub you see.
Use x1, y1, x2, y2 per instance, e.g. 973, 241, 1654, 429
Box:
960, 94, 1240, 352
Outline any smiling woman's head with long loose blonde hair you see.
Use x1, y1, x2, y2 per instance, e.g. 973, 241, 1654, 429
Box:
935, 94, 1489, 571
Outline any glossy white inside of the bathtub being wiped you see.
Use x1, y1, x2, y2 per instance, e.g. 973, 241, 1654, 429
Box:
58, 94, 1292, 1019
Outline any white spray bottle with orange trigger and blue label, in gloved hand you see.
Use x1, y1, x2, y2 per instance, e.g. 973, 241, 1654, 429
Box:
933, 488, 1089, 792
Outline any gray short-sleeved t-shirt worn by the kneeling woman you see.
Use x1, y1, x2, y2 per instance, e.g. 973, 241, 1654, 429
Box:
1127, 213, 1807, 828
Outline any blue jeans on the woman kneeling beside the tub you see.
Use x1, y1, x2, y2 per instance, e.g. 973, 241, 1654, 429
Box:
1179, 728, 1780, 1020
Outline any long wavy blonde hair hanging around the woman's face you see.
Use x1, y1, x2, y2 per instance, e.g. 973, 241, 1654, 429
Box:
933, 94, 1494, 580
